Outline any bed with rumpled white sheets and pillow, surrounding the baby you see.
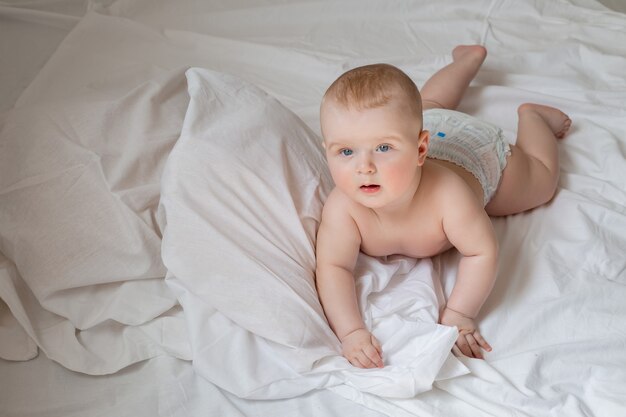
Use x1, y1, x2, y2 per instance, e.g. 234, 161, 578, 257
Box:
0, 0, 626, 417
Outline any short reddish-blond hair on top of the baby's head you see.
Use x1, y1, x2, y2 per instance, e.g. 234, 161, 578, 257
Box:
322, 64, 422, 119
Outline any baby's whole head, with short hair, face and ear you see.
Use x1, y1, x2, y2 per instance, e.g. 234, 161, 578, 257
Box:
320, 64, 428, 208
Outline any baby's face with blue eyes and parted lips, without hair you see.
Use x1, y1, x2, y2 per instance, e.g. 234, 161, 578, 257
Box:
321, 96, 428, 209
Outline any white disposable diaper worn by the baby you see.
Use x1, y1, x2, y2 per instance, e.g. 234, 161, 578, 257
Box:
424, 109, 511, 205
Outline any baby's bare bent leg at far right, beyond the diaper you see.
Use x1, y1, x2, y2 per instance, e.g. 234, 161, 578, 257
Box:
485, 103, 572, 216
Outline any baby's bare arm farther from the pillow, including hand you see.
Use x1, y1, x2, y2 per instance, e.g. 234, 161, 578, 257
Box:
441, 183, 498, 359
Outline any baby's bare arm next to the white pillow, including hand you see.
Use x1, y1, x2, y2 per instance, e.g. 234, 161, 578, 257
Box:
316, 194, 383, 368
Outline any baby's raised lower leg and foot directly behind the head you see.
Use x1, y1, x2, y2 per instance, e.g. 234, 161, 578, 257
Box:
421, 45, 487, 110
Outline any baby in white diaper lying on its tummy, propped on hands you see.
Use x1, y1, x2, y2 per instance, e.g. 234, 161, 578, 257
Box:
316, 45, 571, 368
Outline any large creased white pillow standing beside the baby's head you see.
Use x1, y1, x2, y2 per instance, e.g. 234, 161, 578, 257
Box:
161, 65, 334, 360
